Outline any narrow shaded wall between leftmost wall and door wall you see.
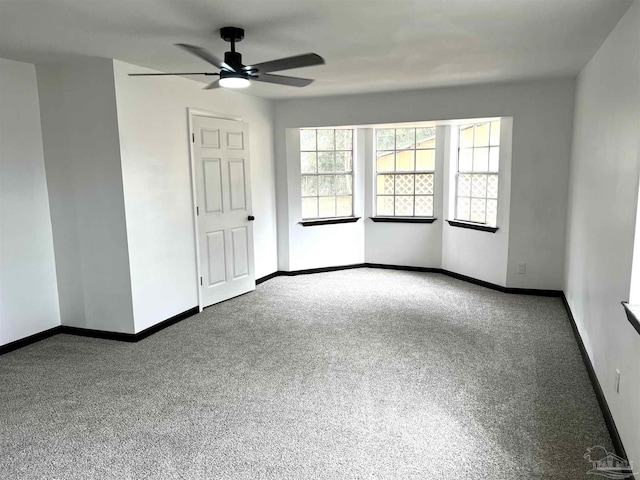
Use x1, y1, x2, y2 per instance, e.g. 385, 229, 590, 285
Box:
36, 58, 133, 333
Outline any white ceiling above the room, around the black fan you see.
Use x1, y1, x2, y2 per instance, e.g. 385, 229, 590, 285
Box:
0, 0, 632, 98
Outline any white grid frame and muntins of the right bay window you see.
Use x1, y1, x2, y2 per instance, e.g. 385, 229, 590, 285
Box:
447, 118, 502, 228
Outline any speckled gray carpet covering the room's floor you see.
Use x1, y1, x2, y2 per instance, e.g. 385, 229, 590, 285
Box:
0, 269, 612, 480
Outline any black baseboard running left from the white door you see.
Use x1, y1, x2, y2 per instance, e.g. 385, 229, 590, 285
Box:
0, 307, 200, 355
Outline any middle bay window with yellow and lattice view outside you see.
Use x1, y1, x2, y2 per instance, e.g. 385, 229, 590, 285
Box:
376, 127, 436, 217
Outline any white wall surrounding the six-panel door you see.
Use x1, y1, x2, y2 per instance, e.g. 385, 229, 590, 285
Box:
113, 61, 277, 332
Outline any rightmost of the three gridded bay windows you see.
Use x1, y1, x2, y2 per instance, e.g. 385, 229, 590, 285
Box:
455, 120, 500, 227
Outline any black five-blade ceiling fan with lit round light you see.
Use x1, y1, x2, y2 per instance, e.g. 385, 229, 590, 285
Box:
129, 27, 324, 90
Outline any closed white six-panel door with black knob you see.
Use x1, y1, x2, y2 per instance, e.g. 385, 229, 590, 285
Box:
192, 115, 256, 307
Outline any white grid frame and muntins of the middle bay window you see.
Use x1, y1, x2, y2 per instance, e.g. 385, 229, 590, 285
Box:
371, 124, 438, 218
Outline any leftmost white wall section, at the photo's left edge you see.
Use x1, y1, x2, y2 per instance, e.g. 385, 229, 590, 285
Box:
0, 59, 60, 345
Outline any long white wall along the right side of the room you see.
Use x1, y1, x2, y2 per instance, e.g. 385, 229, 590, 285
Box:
564, 0, 640, 466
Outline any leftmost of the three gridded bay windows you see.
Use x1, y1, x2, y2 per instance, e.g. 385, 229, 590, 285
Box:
300, 128, 353, 220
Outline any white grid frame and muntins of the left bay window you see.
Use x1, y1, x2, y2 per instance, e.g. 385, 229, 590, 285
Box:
298, 127, 356, 219
